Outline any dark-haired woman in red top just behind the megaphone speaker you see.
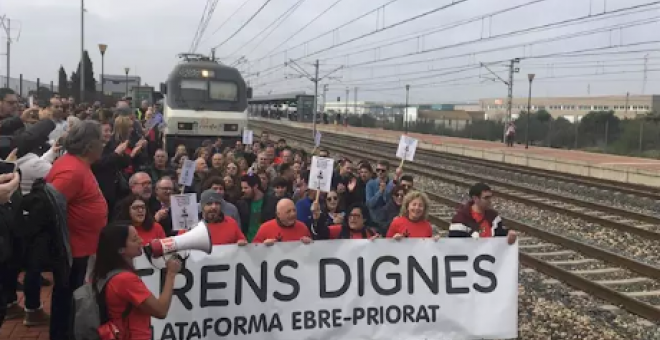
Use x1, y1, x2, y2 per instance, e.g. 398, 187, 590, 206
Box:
116, 195, 167, 245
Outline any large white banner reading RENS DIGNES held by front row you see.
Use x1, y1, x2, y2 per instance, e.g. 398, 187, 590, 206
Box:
136, 238, 518, 340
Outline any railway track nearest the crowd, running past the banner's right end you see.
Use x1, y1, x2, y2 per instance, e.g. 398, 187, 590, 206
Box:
252, 124, 660, 323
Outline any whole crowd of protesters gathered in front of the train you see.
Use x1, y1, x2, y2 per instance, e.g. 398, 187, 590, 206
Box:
0, 89, 515, 340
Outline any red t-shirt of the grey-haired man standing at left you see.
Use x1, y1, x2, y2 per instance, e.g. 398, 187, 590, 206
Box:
46, 154, 108, 257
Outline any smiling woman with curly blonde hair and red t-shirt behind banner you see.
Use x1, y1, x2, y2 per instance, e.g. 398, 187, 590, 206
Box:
387, 191, 433, 240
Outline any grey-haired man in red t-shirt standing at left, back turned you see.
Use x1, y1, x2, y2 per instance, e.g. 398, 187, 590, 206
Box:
46, 120, 108, 340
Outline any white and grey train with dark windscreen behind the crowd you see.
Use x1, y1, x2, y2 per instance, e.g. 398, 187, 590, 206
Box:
163, 54, 252, 155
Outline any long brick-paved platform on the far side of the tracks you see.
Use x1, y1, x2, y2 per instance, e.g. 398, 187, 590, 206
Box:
254, 119, 660, 187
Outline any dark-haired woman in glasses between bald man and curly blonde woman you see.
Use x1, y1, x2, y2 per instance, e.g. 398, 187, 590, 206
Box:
312, 202, 380, 240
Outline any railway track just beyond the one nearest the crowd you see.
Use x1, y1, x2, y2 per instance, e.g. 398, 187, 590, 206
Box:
254, 119, 660, 241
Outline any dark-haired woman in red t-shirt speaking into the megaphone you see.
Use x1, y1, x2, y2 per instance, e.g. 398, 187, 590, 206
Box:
92, 224, 181, 340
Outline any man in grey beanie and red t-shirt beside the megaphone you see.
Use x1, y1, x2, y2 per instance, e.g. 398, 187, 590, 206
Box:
200, 190, 247, 246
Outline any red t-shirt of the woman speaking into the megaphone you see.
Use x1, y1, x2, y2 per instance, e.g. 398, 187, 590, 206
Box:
105, 272, 151, 340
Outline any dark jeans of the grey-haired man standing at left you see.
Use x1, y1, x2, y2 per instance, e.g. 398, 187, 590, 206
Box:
50, 257, 89, 340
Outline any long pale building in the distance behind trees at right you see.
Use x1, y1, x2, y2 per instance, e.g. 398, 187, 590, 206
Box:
479, 95, 660, 121
